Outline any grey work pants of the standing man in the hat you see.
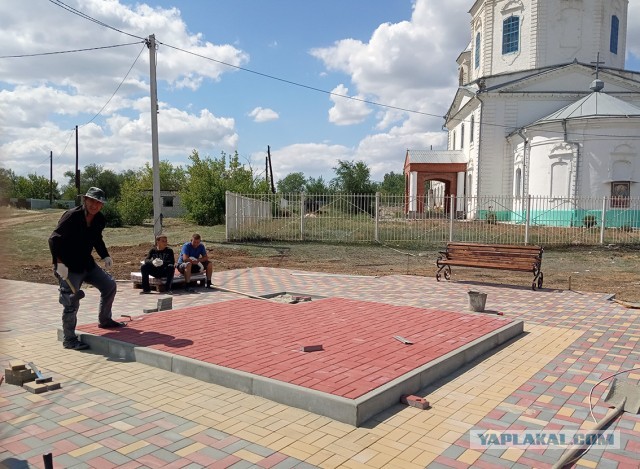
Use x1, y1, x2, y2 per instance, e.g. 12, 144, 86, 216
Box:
58, 266, 117, 343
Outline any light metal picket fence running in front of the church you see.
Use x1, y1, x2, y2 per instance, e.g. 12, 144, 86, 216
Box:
226, 192, 640, 246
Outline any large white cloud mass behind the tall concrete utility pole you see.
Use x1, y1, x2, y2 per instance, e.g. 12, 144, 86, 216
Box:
0, 0, 242, 183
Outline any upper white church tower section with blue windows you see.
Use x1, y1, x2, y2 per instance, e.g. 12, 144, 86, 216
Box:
468, 0, 629, 81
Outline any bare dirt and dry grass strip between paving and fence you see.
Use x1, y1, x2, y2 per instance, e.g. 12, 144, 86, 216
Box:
0, 207, 640, 303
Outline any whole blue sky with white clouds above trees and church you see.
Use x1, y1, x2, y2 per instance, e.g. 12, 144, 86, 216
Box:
0, 0, 640, 184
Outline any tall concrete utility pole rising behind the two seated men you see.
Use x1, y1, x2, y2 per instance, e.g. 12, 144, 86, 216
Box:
146, 34, 162, 238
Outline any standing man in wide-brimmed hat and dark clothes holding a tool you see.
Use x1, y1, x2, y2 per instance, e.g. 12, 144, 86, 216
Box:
49, 187, 125, 350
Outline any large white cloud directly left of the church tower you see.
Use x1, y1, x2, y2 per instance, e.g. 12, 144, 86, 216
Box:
311, 0, 470, 132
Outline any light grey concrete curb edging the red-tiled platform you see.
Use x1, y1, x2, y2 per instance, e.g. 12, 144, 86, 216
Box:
58, 321, 524, 427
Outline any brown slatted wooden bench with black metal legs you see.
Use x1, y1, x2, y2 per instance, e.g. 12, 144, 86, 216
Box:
436, 243, 544, 290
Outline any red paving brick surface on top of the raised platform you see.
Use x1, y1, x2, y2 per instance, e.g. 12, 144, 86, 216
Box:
78, 298, 511, 399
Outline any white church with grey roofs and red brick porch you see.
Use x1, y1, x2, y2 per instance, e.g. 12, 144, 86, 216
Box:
404, 0, 640, 227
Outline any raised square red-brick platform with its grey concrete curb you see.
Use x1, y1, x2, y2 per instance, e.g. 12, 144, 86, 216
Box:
78, 298, 523, 425
